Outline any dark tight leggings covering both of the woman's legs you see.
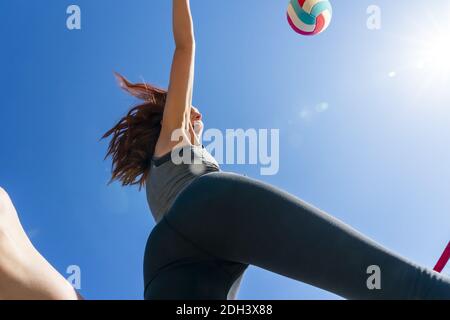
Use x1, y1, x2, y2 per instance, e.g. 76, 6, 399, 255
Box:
144, 172, 450, 300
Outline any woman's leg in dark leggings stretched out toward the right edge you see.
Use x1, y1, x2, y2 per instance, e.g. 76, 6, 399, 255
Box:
166, 172, 450, 299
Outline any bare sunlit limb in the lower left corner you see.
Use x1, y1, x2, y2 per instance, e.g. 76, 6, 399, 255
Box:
0, 188, 80, 300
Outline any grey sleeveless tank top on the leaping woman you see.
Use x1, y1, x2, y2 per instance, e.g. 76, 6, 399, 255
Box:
146, 145, 220, 222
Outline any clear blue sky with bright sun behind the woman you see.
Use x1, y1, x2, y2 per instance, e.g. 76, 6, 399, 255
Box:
0, 0, 450, 299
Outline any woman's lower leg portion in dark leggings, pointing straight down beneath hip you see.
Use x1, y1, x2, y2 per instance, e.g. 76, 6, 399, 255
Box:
144, 218, 248, 300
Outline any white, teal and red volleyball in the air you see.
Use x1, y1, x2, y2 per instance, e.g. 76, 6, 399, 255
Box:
287, 0, 333, 36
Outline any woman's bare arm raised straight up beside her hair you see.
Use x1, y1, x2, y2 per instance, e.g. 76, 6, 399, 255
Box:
155, 0, 195, 153
